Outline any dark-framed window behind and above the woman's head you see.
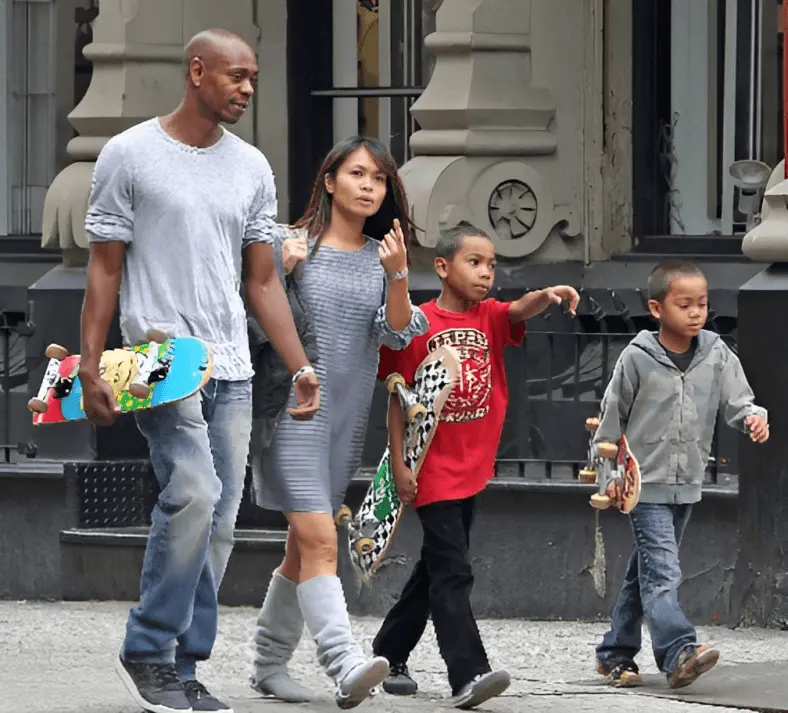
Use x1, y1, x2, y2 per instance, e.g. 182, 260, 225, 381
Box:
287, 0, 425, 215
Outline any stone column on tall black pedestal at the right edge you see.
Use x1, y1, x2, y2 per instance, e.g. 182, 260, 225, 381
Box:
730, 162, 788, 628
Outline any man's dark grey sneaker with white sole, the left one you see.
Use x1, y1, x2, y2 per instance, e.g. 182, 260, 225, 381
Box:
115, 656, 192, 713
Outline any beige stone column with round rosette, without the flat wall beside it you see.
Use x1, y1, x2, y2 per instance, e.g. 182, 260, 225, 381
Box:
401, 0, 582, 259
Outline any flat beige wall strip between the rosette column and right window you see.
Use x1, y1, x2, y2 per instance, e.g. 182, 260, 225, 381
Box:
532, 0, 632, 261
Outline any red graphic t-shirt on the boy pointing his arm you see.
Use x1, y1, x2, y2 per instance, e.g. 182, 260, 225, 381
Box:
378, 299, 525, 507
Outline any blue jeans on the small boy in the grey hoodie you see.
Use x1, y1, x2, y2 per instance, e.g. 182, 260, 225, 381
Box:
596, 503, 697, 674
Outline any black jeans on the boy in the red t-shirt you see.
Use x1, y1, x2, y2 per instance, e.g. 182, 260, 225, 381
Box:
372, 496, 490, 695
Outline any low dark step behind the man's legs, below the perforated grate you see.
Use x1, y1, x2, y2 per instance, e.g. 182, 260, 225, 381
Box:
60, 527, 287, 606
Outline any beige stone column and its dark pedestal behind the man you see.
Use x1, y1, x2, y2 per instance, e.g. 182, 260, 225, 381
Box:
27, 0, 259, 459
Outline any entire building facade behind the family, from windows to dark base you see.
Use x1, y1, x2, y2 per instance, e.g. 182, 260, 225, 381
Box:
0, 0, 783, 621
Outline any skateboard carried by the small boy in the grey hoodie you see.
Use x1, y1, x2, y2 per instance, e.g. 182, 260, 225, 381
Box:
579, 418, 640, 515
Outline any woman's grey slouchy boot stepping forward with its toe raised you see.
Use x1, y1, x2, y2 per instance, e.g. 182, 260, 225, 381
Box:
298, 575, 389, 709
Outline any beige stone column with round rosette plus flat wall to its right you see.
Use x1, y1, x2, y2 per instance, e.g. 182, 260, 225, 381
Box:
402, 0, 631, 262
